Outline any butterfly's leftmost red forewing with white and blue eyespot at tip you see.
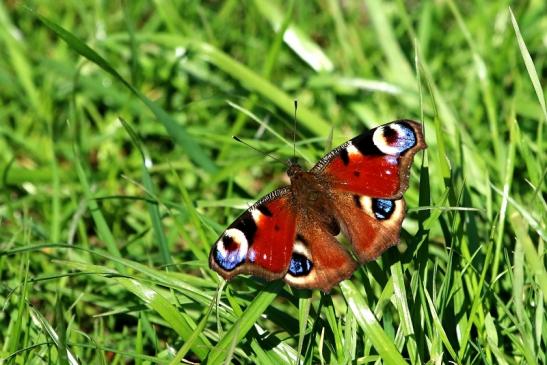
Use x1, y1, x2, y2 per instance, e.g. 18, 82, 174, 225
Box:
209, 188, 296, 280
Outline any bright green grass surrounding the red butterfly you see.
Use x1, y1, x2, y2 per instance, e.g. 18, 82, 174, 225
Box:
0, 0, 547, 364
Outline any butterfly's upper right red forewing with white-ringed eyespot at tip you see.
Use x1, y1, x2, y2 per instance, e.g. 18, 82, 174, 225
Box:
312, 120, 426, 199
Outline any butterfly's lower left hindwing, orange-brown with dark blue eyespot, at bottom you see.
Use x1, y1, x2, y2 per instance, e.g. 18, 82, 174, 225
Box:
284, 222, 357, 292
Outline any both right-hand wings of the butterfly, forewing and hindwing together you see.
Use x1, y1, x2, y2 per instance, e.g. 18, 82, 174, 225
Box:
312, 120, 426, 263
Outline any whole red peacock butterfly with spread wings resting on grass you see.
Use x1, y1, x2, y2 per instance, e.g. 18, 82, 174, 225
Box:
209, 120, 427, 292
